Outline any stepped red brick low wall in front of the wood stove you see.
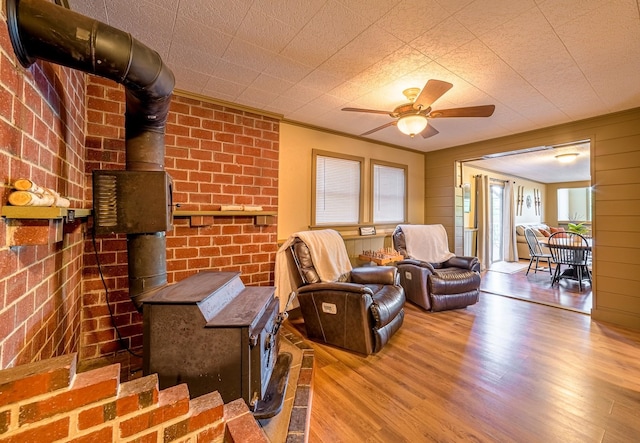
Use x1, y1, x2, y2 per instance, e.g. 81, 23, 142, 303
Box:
0, 354, 268, 443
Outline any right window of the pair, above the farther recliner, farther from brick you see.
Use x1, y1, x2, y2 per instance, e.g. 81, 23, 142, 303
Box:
371, 160, 407, 223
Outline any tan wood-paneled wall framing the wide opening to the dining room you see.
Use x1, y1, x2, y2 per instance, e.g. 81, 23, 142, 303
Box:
425, 108, 640, 330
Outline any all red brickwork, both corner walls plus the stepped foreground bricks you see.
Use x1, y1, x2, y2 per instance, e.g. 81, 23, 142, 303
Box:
0, 18, 279, 443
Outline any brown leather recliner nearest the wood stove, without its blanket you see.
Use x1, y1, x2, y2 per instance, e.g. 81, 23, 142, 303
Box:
289, 238, 405, 354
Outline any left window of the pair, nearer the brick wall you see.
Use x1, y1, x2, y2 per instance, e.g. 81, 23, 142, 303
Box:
312, 150, 364, 225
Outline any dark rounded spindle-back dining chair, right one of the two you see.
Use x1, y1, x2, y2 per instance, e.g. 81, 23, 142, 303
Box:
548, 232, 591, 291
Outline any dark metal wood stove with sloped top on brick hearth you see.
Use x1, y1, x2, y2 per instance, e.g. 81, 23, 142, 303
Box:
143, 272, 291, 418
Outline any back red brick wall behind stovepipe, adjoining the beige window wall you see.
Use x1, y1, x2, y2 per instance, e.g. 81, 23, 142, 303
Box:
80, 76, 279, 359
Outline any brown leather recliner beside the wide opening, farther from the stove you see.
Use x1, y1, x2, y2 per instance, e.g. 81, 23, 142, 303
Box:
393, 226, 480, 311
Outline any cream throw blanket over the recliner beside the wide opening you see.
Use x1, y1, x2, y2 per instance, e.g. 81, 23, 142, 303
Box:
399, 225, 455, 263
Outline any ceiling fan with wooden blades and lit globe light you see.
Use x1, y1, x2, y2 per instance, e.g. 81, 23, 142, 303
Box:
342, 79, 496, 138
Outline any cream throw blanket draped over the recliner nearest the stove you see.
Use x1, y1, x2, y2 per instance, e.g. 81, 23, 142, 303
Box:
275, 229, 352, 312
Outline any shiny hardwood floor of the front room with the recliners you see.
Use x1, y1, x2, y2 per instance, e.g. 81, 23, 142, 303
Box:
285, 293, 640, 443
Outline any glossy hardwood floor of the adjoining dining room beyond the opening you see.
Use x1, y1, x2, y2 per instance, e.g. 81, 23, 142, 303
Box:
480, 260, 593, 314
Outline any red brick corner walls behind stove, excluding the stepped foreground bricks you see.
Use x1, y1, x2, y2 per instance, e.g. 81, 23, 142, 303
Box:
0, 34, 279, 368
